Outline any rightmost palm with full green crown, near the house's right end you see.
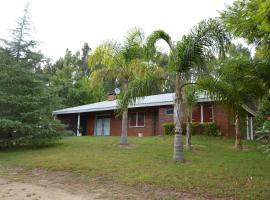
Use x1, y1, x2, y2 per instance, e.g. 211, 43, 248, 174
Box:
199, 45, 264, 149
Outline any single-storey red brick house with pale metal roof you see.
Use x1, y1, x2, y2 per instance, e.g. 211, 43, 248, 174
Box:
53, 93, 255, 139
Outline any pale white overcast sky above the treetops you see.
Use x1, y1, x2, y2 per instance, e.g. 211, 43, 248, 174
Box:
0, 0, 233, 60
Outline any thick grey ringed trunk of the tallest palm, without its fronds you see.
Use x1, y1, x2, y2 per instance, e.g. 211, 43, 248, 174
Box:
173, 73, 184, 162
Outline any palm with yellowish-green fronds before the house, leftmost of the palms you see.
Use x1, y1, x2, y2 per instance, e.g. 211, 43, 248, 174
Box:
88, 28, 160, 145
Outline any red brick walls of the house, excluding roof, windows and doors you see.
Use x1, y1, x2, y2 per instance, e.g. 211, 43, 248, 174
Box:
57, 104, 234, 136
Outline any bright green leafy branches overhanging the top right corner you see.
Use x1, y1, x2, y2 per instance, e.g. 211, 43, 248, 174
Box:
221, 0, 270, 50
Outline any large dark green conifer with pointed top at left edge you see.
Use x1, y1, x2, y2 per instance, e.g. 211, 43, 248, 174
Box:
0, 3, 60, 147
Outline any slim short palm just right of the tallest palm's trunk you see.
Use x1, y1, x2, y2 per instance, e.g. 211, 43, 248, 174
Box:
184, 87, 197, 150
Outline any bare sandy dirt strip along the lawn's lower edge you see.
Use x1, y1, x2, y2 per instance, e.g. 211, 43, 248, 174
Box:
0, 166, 230, 200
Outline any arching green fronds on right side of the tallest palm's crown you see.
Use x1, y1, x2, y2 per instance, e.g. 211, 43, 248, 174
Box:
174, 19, 231, 74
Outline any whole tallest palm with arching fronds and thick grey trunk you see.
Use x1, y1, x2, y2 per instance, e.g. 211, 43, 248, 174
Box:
147, 19, 230, 162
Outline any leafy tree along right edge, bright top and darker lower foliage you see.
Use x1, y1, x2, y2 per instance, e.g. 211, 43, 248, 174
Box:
221, 0, 270, 89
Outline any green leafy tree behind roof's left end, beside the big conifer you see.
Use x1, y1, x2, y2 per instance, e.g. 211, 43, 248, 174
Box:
50, 49, 104, 107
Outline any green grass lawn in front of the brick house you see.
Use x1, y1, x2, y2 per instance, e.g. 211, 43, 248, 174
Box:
0, 136, 270, 199
